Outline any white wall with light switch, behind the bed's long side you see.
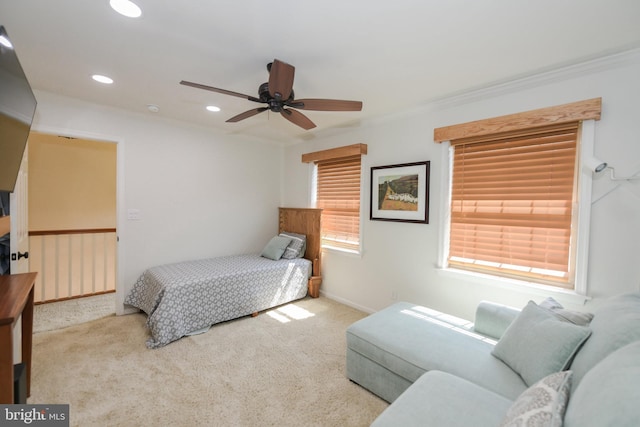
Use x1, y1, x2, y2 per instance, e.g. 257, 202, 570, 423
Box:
27, 92, 282, 312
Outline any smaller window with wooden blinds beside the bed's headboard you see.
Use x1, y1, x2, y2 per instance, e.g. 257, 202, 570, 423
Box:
302, 144, 367, 252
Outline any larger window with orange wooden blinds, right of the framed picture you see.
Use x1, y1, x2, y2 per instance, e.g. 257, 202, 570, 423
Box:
435, 99, 600, 289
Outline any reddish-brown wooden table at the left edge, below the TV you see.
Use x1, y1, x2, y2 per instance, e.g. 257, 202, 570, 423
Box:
0, 273, 37, 404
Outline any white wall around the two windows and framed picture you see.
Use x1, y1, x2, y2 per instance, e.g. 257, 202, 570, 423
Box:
283, 50, 640, 319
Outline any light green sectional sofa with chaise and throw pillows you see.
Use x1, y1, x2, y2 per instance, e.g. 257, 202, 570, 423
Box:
346, 293, 640, 427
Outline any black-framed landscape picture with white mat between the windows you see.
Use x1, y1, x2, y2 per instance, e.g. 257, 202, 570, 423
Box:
370, 161, 431, 224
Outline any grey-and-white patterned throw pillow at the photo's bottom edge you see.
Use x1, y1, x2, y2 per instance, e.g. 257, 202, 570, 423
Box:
500, 371, 573, 427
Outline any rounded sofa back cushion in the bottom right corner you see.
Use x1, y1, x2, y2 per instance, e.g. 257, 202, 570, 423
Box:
564, 342, 640, 427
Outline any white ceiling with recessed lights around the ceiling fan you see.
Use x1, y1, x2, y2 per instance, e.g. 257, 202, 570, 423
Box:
0, 0, 640, 142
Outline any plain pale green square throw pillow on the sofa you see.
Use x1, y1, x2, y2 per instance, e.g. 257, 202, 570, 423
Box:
491, 301, 591, 386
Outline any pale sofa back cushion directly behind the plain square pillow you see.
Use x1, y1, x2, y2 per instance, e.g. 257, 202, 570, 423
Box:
571, 293, 640, 389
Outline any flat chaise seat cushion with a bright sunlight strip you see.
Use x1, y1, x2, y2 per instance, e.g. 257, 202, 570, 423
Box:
346, 302, 527, 399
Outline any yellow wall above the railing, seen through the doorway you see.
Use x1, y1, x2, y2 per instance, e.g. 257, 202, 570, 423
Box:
29, 132, 116, 231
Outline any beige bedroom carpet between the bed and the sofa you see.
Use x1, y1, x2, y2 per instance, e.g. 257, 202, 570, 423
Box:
28, 298, 387, 426
